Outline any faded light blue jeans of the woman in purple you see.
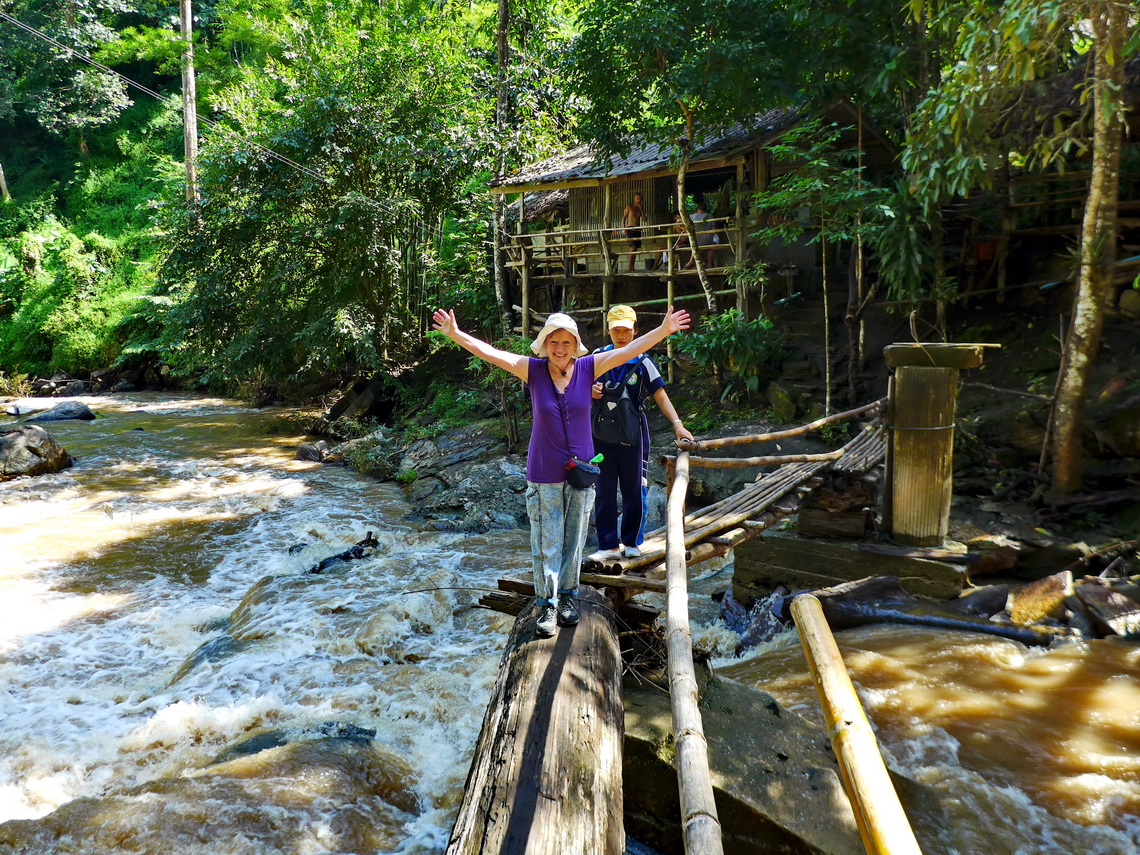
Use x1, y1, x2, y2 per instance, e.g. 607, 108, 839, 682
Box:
527, 481, 594, 604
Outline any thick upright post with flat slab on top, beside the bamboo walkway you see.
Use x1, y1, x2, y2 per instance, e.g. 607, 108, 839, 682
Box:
884, 343, 982, 546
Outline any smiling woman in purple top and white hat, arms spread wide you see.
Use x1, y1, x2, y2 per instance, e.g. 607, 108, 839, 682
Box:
432, 306, 689, 638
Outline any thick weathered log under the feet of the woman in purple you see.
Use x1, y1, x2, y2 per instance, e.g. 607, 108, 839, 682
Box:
447, 586, 626, 855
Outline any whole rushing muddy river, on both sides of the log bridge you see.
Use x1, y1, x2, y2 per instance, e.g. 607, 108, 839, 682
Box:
0, 394, 1140, 855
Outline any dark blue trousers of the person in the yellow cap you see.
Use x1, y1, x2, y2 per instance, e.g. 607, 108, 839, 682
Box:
594, 416, 649, 549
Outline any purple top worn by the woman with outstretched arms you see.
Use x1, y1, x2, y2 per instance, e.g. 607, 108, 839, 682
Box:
527, 355, 594, 483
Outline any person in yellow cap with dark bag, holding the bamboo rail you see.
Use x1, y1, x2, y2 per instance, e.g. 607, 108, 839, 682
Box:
589, 306, 693, 562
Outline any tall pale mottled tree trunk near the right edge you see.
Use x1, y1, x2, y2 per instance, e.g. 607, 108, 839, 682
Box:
1050, 2, 1129, 500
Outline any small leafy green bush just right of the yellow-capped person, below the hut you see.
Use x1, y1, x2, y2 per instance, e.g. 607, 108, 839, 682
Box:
676, 309, 787, 401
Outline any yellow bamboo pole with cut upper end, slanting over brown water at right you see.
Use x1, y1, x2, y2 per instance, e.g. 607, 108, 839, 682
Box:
791, 594, 921, 855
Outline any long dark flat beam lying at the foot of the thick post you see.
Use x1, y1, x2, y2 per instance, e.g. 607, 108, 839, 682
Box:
732, 535, 968, 608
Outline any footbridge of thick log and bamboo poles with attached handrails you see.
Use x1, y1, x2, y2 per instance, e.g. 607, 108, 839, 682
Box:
447, 401, 886, 855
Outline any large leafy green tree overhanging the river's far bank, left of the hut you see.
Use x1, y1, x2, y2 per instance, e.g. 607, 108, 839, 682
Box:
153, 0, 479, 381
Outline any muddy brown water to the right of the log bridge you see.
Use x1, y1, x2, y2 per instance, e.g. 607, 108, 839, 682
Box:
717, 626, 1140, 855
